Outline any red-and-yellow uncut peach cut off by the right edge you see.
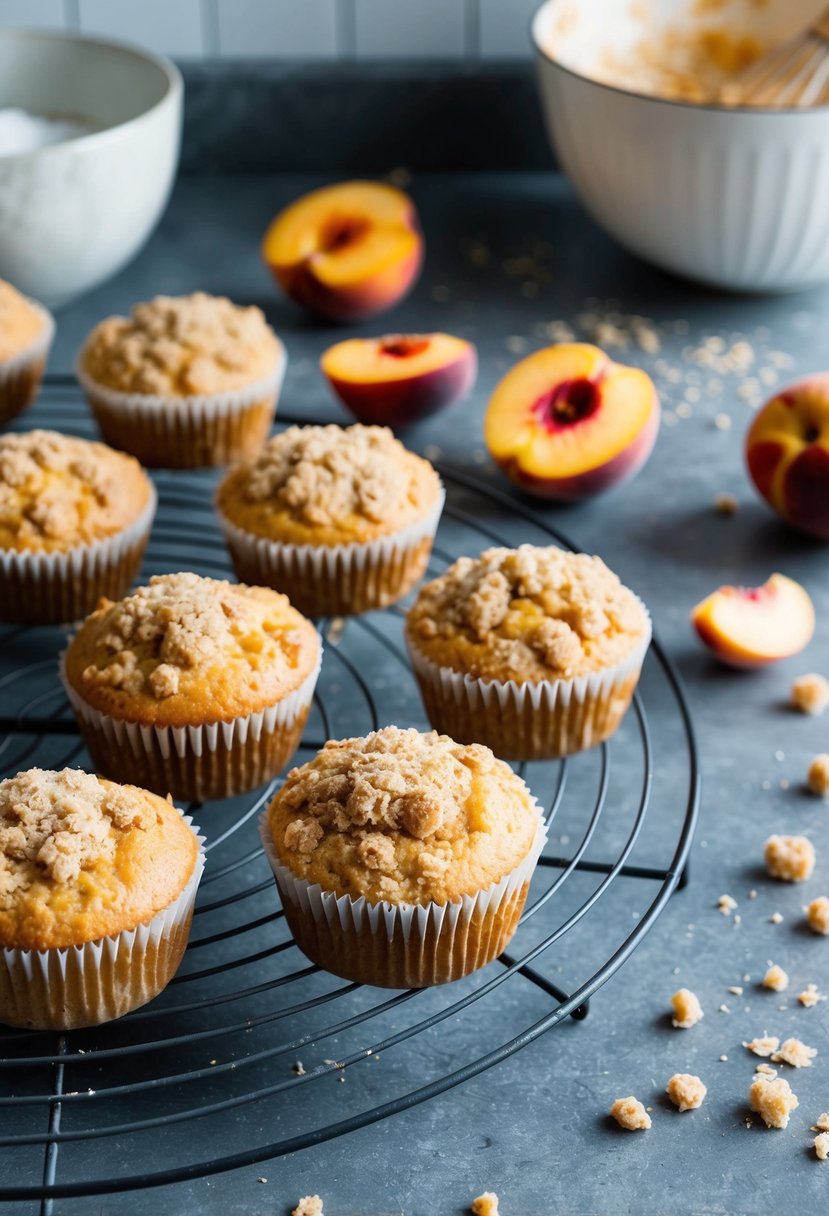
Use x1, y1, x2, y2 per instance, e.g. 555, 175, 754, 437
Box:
745, 372, 829, 540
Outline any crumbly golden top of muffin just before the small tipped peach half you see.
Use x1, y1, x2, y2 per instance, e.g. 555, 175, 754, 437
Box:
216, 424, 441, 545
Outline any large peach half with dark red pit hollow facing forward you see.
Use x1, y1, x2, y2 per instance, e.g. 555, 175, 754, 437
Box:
484, 343, 660, 501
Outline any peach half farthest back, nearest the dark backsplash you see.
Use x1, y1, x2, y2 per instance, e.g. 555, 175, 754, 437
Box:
263, 181, 423, 321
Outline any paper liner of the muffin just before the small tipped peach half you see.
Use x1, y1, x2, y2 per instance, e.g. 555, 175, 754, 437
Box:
219, 488, 446, 617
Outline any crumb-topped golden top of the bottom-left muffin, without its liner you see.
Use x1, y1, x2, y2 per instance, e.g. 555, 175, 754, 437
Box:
0, 769, 198, 950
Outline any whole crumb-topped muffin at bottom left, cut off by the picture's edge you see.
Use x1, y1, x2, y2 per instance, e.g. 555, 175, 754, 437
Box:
0, 769, 204, 1030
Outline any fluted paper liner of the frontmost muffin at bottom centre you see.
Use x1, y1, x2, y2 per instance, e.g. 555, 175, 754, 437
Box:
259, 807, 547, 989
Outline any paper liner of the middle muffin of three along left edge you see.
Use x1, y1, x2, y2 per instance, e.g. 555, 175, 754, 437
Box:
0, 485, 157, 627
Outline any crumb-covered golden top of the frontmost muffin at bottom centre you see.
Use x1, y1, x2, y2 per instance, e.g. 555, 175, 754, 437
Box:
267, 726, 541, 903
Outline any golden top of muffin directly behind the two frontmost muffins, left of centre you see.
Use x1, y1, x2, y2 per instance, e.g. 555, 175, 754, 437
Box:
66, 574, 320, 726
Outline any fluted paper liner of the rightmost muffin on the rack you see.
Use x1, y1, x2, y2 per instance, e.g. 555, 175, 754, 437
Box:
406, 604, 650, 760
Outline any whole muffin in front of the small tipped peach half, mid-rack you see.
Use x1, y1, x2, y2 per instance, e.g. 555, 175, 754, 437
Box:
216, 426, 444, 617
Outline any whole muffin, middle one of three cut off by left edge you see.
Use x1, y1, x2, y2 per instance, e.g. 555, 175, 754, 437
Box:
0, 430, 156, 624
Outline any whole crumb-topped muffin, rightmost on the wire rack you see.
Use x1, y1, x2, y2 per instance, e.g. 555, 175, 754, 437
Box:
406, 545, 650, 760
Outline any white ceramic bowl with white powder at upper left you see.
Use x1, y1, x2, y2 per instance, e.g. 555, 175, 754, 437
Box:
0, 29, 184, 308
